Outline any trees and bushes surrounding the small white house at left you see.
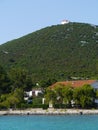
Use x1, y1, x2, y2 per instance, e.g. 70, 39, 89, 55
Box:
0, 66, 55, 110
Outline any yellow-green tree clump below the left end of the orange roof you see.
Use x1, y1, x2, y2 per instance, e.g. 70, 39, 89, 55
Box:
45, 84, 73, 107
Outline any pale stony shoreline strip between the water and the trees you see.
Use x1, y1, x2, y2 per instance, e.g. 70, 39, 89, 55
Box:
0, 108, 98, 116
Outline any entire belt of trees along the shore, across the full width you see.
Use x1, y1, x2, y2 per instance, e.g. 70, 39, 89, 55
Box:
0, 66, 98, 110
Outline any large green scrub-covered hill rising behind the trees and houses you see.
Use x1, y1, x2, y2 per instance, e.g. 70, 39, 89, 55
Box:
0, 23, 98, 81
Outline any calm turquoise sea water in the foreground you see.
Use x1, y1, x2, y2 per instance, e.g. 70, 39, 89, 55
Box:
0, 115, 98, 130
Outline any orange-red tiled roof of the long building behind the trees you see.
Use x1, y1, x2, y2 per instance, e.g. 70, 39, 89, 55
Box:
50, 80, 96, 88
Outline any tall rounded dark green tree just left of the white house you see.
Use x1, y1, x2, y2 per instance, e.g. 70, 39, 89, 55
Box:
9, 68, 32, 91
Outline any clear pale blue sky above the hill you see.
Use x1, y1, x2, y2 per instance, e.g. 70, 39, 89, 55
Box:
0, 0, 98, 44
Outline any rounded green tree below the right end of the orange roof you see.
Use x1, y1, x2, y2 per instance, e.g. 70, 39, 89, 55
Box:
73, 85, 96, 108
